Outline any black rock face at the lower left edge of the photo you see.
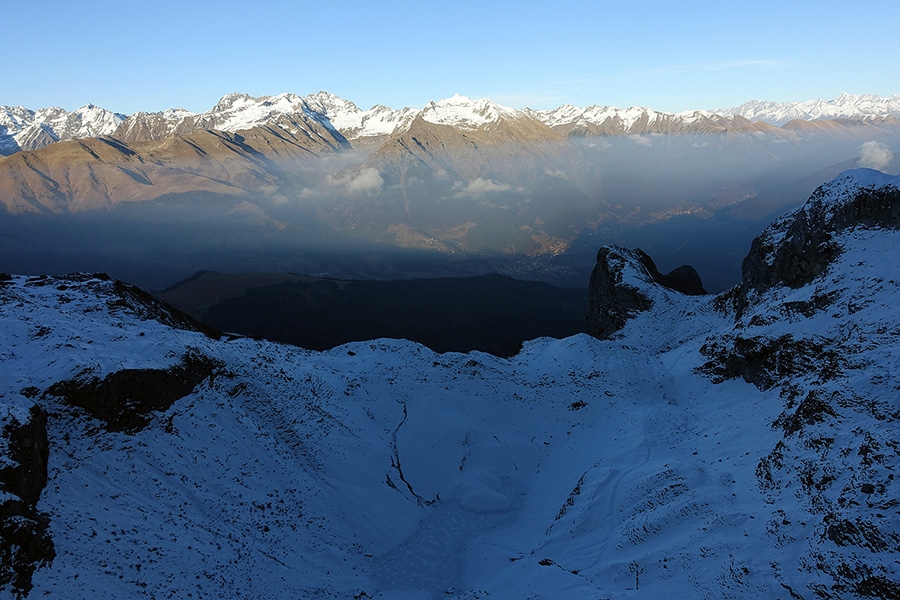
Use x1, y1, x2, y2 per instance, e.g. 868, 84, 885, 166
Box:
0, 404, 56, 598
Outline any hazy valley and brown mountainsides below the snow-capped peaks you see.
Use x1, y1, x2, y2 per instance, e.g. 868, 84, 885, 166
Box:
0, 107, 900, 292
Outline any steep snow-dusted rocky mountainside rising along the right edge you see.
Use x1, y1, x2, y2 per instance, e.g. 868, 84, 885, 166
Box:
697, 170, 900, 598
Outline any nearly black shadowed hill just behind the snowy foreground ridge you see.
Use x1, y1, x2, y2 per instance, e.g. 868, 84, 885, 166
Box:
186, 274, 587, 356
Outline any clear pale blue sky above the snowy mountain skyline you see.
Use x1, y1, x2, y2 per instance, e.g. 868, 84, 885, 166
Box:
8, 0, 900, 113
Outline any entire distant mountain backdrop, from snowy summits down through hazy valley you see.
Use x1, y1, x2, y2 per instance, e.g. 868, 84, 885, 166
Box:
0, 92, 900, 290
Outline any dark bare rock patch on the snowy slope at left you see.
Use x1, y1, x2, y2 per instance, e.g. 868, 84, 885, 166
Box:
45, 354, 219, 432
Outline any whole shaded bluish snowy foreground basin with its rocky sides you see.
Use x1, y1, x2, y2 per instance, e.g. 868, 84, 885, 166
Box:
0, 171, 900, 599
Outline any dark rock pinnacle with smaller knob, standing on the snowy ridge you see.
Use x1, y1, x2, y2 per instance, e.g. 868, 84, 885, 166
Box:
586, 246, 706, 339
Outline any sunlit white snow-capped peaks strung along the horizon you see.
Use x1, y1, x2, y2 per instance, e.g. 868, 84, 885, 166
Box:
0, 92, 900, 155
